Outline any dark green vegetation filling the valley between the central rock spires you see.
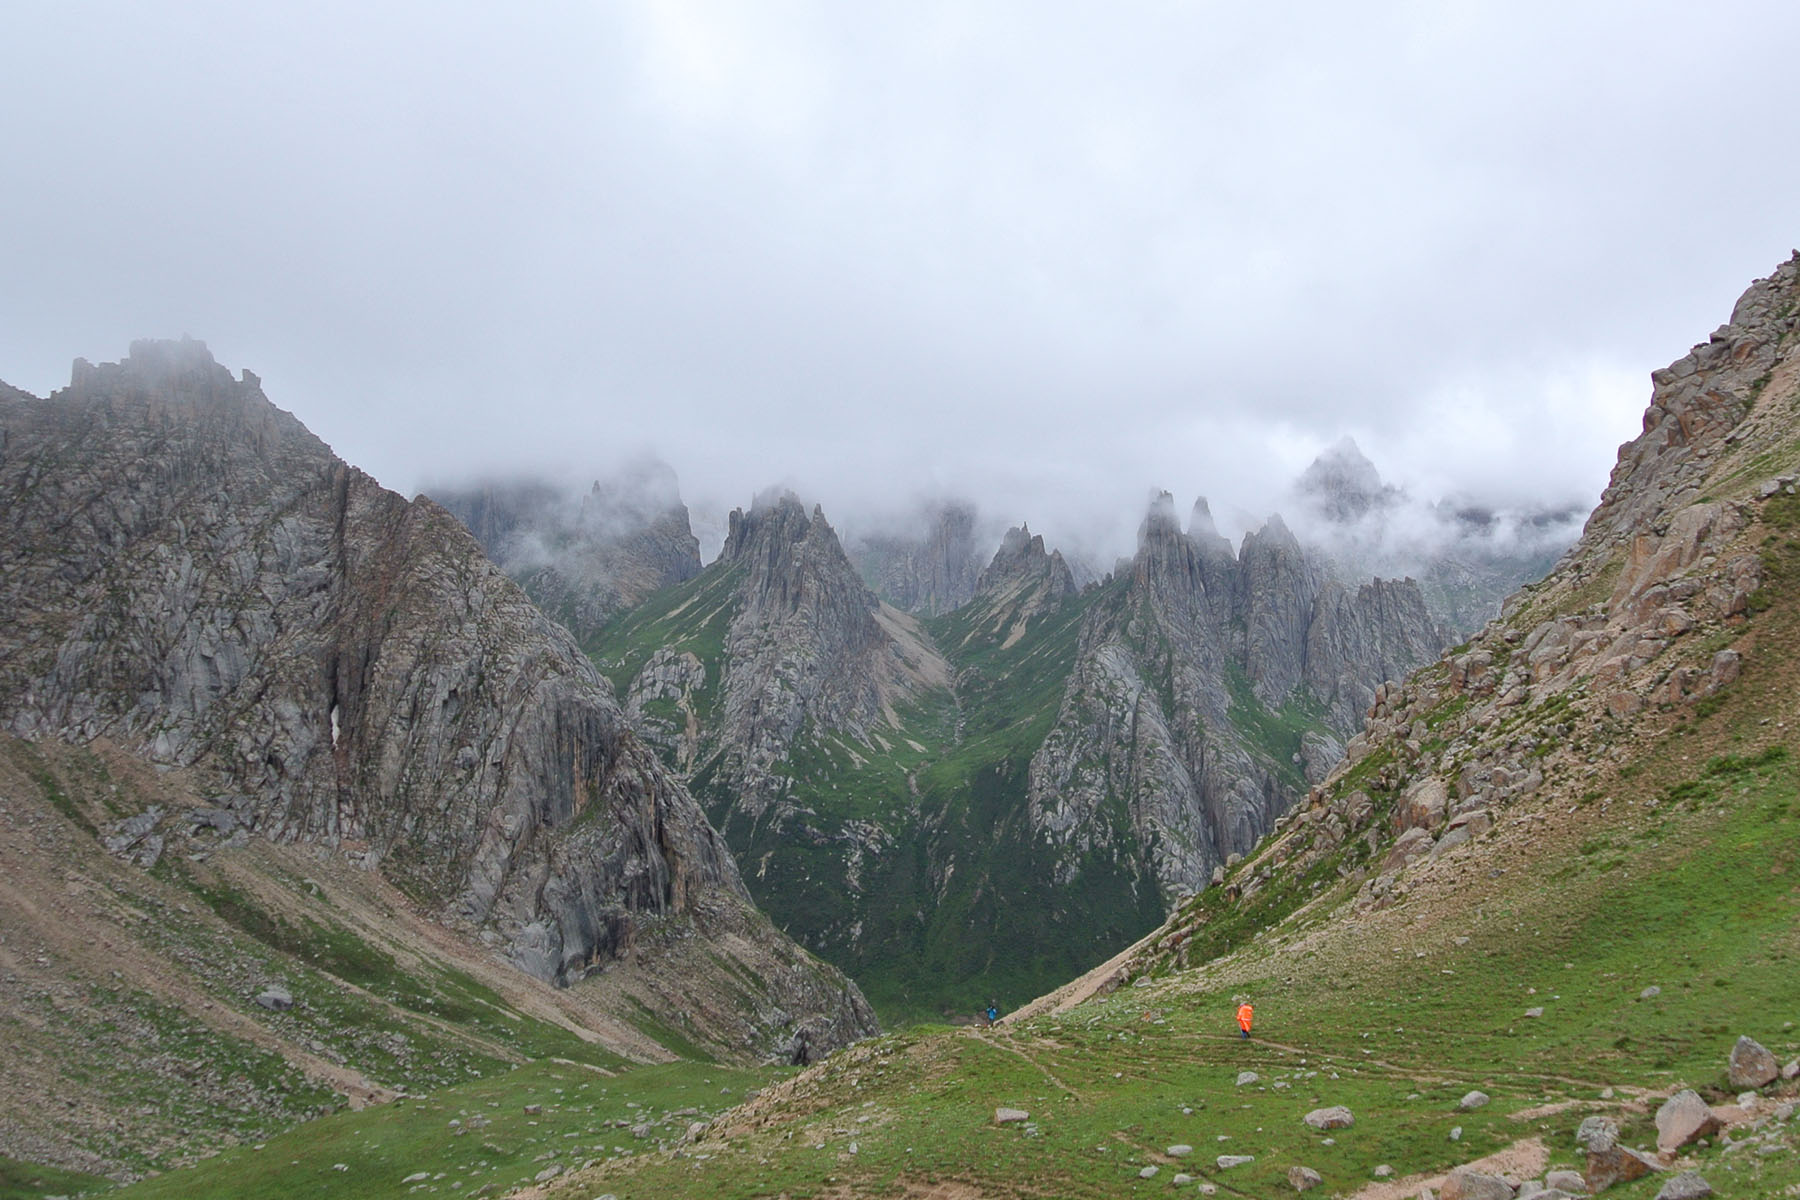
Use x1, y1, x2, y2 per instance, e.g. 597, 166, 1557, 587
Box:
594, 565, 1163, 1024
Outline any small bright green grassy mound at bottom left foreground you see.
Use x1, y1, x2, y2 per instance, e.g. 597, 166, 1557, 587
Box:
110, 1061, 769, 1200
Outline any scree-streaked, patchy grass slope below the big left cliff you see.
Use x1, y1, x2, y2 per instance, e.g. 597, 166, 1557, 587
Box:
0, 739, 752, 1193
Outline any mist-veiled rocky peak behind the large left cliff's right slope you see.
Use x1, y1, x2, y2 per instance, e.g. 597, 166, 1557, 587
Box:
430, 461, 700, 644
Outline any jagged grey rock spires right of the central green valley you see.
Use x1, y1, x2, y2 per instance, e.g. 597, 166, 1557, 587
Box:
1030, 493, 1444, 898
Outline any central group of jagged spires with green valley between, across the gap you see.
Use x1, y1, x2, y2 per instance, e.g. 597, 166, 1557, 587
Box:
596, 467, 1442, 1015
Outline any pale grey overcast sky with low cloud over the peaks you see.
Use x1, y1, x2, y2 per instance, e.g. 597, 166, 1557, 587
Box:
0, 0, 1800, 557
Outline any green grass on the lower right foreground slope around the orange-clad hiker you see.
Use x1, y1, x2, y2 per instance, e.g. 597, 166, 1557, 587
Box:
553, 723, 1800, 1200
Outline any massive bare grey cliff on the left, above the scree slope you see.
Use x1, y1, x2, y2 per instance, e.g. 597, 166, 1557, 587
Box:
0, 342, 873, 1051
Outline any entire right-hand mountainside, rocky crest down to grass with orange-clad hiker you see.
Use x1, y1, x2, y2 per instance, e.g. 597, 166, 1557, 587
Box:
532, 257, 1800, 1200
